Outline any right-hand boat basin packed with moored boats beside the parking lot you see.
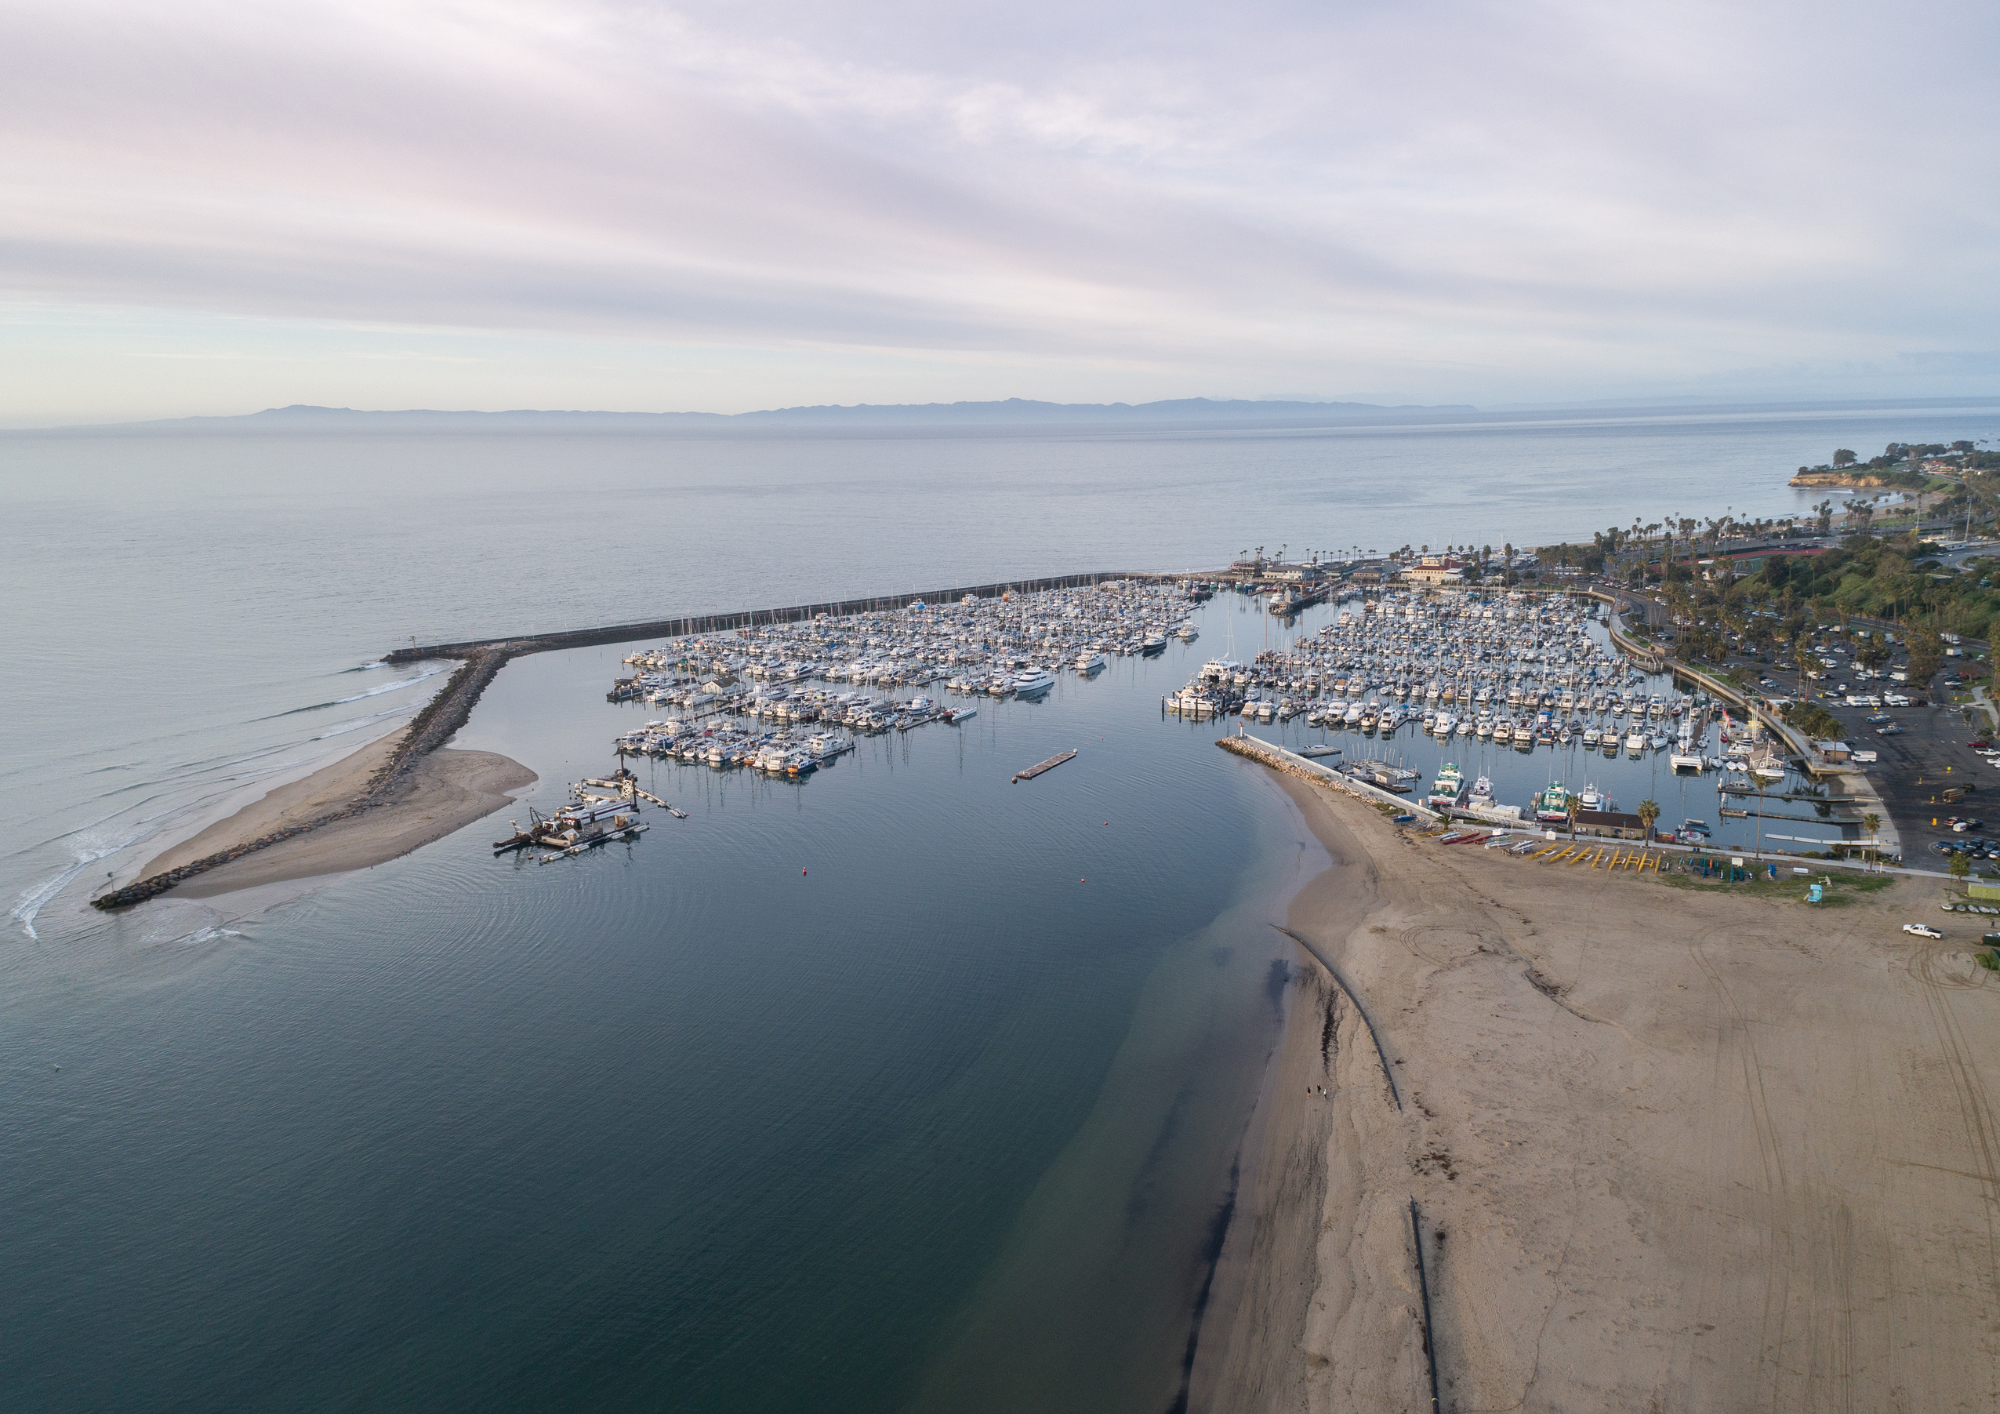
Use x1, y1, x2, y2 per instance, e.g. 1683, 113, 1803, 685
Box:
1162, 590, 1862, 852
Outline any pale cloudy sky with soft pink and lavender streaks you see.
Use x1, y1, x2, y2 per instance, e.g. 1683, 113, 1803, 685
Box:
0, 0, 2000, 426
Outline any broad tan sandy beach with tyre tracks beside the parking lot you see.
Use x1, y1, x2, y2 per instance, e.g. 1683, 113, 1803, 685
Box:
1190, 764, 2000, 1412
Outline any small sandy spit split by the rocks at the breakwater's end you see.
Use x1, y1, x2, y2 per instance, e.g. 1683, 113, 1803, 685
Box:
140, 732, 536, 898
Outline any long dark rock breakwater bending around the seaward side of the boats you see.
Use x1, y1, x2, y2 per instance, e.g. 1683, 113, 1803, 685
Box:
90, 570, 1162, 910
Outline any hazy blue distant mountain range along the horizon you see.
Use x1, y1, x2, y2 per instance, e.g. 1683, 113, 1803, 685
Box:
86, 398, 1476, 430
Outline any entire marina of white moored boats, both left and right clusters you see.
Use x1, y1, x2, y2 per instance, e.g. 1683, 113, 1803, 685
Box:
560, 576, 1860, 864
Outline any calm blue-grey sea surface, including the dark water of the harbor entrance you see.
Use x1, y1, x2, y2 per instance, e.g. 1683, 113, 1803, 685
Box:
0, 408, 2000, 1410
